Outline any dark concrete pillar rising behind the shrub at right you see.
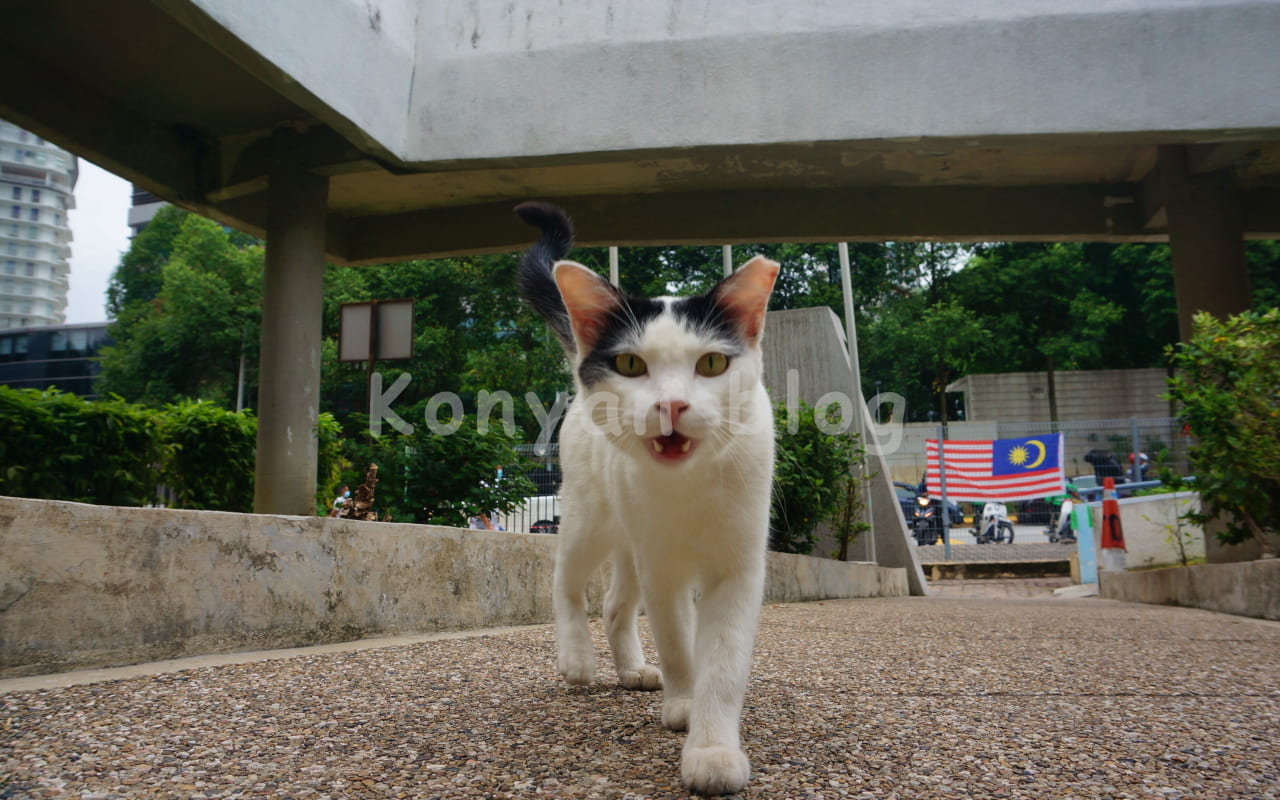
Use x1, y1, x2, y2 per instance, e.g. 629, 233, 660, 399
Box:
1160, 146, 1253, 342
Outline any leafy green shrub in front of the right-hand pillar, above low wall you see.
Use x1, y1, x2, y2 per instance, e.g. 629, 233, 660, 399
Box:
1167, 308, 1280, 544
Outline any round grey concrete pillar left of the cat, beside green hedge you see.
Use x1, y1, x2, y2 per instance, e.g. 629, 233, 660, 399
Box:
253, 128, 329, 516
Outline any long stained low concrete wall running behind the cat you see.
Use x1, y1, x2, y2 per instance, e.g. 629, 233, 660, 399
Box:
0, 497, 906, 677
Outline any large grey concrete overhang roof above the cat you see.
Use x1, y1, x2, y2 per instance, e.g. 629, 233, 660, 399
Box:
0, 0, 1280, 264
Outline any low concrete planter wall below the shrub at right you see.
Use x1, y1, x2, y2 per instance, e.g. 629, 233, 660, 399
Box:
1098, 558, 1280, 620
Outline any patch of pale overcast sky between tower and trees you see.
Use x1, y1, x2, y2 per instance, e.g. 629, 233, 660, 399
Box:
67, 159, 133, 323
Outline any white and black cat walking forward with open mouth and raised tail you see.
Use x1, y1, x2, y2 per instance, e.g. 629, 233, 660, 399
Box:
516, 202, 778, 794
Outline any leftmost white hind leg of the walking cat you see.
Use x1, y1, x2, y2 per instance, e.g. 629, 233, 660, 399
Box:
552, 515, 612, 686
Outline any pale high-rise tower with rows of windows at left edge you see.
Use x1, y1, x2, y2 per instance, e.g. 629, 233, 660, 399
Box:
0, 120, 79, 329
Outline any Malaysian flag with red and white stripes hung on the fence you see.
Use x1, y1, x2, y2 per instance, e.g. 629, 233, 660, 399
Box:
925, 434, 1066, 503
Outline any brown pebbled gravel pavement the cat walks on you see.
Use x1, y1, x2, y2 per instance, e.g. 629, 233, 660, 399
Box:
0, 581, 1280, 800
